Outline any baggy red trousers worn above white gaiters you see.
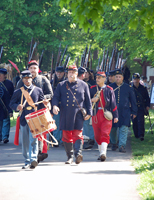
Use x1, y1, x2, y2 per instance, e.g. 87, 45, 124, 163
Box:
92, 110, 112, 145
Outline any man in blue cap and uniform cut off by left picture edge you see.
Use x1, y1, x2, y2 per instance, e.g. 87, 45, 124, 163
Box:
0, 68, 14, 143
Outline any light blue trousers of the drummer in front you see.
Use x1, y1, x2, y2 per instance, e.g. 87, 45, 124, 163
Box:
20, 124, 38, 164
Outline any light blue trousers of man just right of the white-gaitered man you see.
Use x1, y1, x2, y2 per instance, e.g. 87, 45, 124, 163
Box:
110, 125, 128, 148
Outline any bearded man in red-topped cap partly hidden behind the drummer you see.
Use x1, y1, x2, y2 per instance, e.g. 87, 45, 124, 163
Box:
16, 60, 53, 161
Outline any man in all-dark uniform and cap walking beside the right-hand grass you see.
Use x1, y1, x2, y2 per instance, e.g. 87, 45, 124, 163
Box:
132, 73, 150, 141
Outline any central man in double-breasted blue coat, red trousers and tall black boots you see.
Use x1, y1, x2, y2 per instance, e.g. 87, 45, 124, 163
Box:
52, 65, 92, 164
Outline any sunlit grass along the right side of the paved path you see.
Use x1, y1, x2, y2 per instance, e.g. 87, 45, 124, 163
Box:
131, 110, 154, 200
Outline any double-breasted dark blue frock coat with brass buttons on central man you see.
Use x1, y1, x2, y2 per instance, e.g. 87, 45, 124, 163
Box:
52, 79, 92, 130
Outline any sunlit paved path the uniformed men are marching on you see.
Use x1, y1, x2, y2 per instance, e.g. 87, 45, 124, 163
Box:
0, 127, 140, 200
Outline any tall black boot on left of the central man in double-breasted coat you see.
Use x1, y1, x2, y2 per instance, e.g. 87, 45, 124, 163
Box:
63, 142, 73, 164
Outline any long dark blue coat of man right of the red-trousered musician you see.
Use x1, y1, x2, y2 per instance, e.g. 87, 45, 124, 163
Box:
110, 83, 137, 127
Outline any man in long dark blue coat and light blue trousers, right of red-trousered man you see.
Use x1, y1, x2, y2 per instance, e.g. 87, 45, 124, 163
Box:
110, 69, 137, 153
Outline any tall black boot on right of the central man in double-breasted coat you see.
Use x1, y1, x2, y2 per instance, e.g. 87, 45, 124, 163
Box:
74, 139, 83, 164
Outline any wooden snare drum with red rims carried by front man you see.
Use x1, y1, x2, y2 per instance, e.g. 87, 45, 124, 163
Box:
25, 108, 57, 138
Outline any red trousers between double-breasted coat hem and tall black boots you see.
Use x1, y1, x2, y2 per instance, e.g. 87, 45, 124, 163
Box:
62, 130, 83, 144
